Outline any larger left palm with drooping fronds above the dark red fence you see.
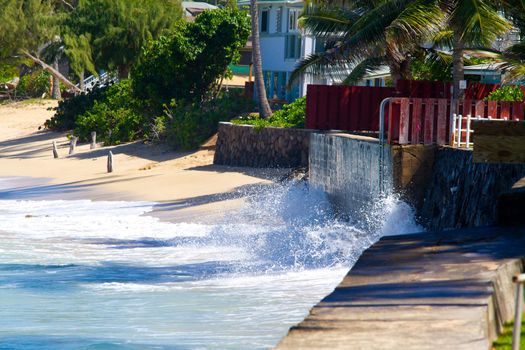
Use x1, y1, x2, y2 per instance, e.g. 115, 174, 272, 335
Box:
289, 0, 445, 85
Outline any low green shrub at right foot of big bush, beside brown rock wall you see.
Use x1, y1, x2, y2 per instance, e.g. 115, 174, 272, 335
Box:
167, 93, 254, 149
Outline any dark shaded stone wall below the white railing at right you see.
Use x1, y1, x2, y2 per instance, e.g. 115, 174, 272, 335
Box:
419, 147, 525, 230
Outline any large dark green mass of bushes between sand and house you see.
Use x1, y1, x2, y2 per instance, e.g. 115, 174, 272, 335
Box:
46, 8, 253, 149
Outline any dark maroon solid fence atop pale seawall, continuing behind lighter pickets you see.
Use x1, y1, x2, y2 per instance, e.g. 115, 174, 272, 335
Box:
306, 80, 525, 131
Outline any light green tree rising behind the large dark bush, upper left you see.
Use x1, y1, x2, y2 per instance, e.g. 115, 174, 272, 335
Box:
65, 0, 182, 79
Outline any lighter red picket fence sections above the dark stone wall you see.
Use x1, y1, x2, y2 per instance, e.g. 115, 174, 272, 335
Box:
385, 97, 525, 145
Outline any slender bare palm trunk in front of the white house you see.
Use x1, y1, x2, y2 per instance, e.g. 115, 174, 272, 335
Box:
250, 0, 272, 118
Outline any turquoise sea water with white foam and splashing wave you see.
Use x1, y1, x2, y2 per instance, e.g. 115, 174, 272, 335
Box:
0, 181, 420, 349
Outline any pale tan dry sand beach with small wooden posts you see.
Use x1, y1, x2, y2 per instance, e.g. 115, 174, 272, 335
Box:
0, 101, 283, 220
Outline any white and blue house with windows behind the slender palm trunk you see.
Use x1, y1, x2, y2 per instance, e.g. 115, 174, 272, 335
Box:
238, 0, 327, 101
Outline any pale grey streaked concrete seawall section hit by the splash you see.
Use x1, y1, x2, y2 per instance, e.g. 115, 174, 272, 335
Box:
309, 133, 393, 215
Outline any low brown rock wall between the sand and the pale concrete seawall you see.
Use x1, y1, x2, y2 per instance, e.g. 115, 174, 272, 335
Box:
213, 123, 313, 168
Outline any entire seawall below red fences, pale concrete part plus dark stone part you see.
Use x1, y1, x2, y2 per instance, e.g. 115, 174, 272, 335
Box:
310, 133, 525, 230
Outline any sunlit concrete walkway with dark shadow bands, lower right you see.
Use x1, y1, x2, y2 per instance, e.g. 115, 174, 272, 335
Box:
277, 228, 525, 350
